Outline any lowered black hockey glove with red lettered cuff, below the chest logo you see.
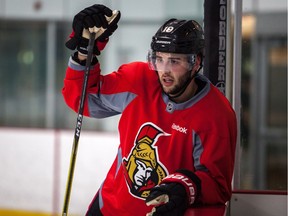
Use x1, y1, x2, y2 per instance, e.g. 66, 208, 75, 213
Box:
146, 170, 201, 216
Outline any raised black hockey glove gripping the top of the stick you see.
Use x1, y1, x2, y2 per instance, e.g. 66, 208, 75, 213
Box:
65, 4, 120, 55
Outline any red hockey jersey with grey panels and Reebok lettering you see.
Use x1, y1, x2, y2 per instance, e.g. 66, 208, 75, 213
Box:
62, 60, 237, 216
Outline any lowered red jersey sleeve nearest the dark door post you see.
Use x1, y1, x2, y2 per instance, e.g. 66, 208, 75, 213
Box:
195, 86, 237, 204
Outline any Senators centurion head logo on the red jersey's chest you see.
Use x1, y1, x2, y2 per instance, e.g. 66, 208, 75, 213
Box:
123, 123, 170, 199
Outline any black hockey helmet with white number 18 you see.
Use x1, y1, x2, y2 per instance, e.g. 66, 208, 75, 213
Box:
151, 19, 204, 57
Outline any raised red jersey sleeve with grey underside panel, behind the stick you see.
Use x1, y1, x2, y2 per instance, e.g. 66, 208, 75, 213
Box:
62, 59, 145, 118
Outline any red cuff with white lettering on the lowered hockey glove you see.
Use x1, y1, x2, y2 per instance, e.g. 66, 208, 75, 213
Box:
161, 170, 201, 205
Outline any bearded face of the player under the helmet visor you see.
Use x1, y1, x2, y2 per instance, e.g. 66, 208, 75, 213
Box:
155, 52, 191, 96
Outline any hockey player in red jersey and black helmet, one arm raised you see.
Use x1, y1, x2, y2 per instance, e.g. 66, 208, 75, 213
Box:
63, 5, 237, 216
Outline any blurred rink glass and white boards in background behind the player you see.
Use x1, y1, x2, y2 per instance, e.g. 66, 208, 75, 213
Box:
0, 0, 287, 216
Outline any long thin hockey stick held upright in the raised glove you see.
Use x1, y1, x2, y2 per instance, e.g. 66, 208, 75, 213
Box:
62, 10, 120, 216
